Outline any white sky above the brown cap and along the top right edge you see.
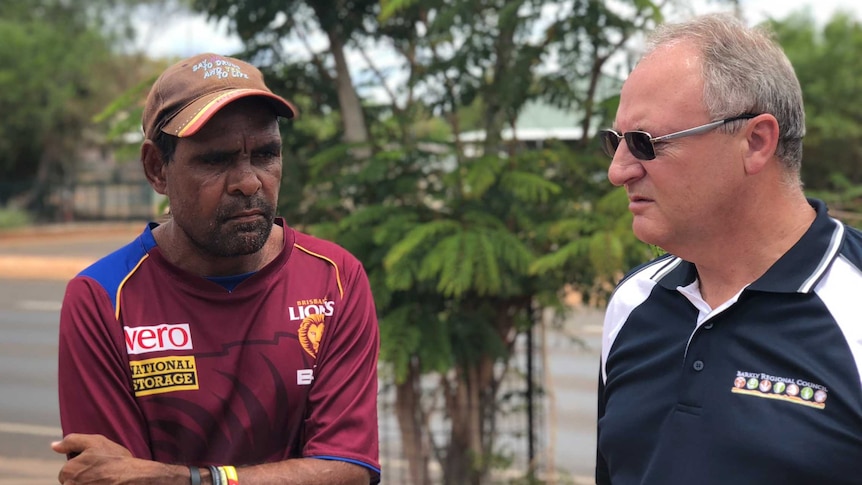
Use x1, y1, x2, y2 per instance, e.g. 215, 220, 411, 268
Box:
137, 0, 862, 57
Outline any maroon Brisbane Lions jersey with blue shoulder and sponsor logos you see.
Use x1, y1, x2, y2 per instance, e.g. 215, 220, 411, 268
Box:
59, 219, 380, 482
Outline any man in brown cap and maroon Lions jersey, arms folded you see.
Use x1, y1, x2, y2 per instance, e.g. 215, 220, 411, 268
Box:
52, 54, 380, 485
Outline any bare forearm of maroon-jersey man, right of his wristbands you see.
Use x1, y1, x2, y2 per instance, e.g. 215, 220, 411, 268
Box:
194, 458, 370, 485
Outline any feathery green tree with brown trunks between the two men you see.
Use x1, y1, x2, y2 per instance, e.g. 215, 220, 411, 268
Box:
187, 0, 659, 484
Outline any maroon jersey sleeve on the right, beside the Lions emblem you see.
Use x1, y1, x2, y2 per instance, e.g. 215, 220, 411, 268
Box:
303, 255, 380, 482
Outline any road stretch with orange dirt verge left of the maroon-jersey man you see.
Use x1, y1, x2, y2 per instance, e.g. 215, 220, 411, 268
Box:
0, 223, 143, 485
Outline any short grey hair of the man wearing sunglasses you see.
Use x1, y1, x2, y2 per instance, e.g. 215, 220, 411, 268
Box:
644, 13, 805, 178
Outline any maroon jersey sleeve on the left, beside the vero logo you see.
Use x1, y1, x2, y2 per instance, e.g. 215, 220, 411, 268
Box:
58, 276, 152, 459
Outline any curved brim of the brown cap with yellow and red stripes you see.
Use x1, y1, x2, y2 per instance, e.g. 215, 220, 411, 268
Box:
162, 89, 298, 138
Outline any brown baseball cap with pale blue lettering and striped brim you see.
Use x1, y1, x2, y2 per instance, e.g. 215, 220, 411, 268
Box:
142, 53, 298, 140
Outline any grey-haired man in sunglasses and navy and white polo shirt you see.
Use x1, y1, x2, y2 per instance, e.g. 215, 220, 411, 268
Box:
596, 11, 862, 485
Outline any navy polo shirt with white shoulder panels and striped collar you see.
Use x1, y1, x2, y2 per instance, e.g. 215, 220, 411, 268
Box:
596, 200, 862, 485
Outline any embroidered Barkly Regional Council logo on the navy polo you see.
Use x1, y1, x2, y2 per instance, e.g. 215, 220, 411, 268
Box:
730, 371, 829, 409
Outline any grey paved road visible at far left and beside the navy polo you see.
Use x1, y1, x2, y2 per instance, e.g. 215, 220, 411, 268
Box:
0, 223, 601, 485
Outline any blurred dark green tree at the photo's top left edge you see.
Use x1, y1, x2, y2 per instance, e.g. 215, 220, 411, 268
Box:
0, 0, 121, 214
